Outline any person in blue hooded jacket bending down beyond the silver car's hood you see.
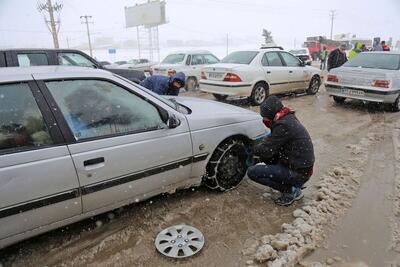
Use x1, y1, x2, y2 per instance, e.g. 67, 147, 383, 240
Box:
140, 72, 185, 95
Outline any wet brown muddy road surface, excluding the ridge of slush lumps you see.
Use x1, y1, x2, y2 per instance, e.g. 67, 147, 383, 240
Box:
0, 89, 400, 267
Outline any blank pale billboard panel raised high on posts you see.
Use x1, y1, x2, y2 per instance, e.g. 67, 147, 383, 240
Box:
125, 1, 166, 28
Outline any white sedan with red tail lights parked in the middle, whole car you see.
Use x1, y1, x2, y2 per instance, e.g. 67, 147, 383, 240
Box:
200, 48, 322, 105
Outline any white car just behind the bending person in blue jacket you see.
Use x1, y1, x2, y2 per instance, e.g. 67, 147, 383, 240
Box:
152, 51, 219, 90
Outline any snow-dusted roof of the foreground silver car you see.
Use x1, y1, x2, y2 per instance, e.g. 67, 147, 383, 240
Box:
0, 66, 113, 83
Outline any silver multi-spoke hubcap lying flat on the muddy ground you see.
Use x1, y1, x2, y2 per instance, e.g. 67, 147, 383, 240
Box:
155, 224, 204, 258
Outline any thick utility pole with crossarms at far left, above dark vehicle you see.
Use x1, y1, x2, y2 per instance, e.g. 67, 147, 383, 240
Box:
38, 0, 63, 48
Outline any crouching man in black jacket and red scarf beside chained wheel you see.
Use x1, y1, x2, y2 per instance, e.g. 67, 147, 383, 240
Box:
247, 96, 314, 206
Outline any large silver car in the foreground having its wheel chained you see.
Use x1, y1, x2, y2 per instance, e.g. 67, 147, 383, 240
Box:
0, 66, 266, 248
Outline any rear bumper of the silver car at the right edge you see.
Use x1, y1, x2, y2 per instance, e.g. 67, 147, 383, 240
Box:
325, 83, 400, 103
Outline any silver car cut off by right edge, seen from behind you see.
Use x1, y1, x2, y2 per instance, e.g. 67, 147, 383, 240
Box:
325, 52, 400, 111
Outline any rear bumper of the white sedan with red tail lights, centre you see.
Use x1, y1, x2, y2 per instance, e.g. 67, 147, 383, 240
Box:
199, 81, 253, 96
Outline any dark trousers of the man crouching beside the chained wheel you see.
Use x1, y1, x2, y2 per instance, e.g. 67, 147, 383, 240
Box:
247, 164, 310, 193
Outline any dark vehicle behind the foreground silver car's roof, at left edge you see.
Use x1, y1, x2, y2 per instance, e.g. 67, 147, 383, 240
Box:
0, 49, 146, 83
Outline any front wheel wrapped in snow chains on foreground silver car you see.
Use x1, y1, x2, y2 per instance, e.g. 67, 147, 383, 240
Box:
204, 139, 247, 191
